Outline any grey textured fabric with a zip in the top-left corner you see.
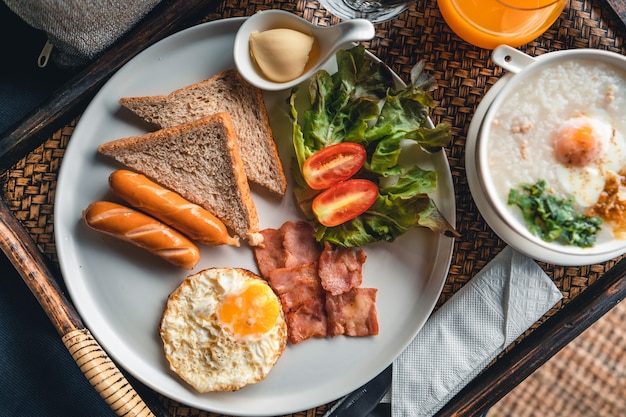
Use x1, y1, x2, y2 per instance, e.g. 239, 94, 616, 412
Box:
3, 0, 161, 67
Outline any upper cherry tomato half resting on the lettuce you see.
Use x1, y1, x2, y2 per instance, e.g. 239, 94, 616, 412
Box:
302, 142, 367, 190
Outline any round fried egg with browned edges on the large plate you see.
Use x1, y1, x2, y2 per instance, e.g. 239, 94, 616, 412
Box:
160, 268, 287, 392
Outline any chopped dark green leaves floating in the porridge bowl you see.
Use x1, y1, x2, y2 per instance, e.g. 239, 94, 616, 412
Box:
508, 180, 602, 247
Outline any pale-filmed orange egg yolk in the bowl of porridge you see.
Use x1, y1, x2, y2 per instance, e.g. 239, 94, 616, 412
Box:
554, 117, 602, 167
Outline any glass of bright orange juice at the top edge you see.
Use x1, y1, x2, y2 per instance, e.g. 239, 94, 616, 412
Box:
437, 0, 567, 49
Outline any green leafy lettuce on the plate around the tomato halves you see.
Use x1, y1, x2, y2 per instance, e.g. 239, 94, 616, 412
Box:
289, 45, 458, 247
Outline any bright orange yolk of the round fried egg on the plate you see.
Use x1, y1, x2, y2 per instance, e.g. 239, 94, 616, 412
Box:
217, 283, 280, 337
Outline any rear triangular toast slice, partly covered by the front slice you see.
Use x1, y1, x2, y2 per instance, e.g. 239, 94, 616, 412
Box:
120, 69, 287, 196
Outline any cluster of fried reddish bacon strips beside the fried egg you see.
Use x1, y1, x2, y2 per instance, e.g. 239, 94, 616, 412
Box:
254, 221, 378, 344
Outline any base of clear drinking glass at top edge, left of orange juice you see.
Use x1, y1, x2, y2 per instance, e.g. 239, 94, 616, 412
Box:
320, 0, 415, 23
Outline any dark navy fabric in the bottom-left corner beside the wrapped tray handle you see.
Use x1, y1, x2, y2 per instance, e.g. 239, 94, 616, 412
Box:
0, 252, 115, 417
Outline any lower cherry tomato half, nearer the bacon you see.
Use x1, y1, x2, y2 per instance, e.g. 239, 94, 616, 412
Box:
311, 179, 378, 227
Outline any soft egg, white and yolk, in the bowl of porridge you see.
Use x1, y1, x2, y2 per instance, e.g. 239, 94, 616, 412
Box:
553, 111, 626, 208
